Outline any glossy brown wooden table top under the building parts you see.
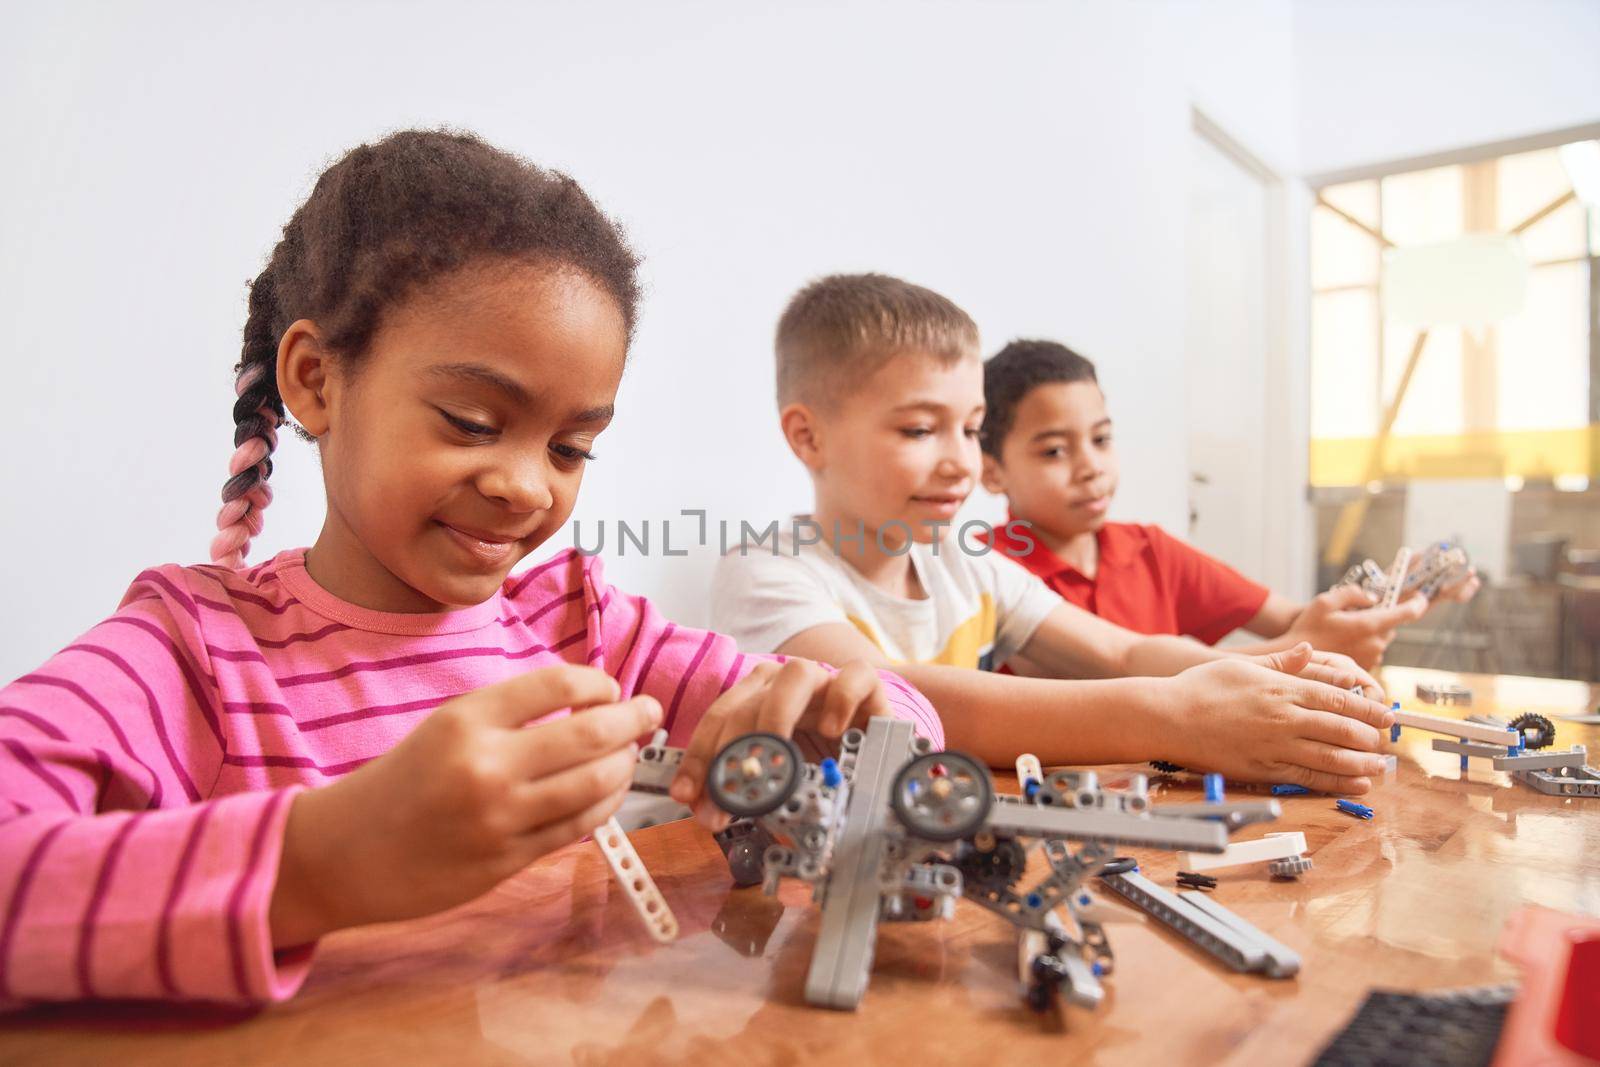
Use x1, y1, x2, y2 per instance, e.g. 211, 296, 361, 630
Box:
0, 669, 1600, 1067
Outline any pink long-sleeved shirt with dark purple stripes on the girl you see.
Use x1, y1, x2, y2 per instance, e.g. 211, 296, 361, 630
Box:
0, 549, 944, 1005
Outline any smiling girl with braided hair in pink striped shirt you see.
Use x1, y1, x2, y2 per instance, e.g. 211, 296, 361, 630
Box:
0, 131, 942, 1003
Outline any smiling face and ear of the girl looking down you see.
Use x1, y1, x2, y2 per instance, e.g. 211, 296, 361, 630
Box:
278, 261, 627, 611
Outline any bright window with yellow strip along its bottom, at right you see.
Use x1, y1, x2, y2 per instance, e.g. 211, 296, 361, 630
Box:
1310, 141, 1600, 486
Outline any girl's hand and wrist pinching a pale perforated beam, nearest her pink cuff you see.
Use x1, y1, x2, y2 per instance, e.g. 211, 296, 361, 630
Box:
269, 665, 661, 947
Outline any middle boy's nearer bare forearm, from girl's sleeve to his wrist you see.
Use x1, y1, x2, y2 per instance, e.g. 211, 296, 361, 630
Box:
896, 664, 1174, 768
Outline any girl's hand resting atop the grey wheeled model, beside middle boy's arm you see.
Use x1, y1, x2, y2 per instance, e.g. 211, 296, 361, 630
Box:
669, 659, 891, 830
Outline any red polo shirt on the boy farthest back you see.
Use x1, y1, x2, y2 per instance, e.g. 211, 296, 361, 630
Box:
994, 522, 1270, 645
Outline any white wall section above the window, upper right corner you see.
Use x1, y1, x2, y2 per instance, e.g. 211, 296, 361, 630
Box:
1294, 0, 1600, 174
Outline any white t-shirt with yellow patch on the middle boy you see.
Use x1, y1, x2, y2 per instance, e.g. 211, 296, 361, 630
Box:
710, 515, 1061, 670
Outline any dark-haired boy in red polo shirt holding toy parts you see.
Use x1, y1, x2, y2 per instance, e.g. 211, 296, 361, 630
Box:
981, 341, 1478, 669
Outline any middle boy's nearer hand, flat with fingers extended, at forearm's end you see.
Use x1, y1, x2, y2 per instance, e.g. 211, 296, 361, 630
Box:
1152, 659, 1394, 793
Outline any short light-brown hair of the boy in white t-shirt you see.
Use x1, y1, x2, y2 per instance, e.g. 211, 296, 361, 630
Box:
774, 274, 981, 406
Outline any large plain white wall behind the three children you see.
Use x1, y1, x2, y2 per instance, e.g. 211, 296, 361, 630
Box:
0, 0, 1350, 678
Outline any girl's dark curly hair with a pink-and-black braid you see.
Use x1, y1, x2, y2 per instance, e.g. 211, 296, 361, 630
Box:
211, 130, 640, 566
